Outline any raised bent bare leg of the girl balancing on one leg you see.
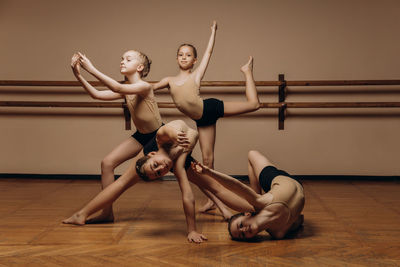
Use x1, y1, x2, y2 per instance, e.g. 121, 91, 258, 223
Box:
224, 57, 260, 117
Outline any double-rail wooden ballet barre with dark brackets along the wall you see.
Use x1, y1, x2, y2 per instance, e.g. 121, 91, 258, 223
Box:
0, 74, 400, 130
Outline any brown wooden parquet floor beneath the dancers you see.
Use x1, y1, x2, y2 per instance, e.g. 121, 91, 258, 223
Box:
0, 179, 400, 266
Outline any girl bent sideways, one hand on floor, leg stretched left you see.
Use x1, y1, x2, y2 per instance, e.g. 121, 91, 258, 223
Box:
63, 120, 207, 243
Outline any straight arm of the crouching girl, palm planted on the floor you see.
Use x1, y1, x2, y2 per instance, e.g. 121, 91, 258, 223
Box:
174, 153, 207, 243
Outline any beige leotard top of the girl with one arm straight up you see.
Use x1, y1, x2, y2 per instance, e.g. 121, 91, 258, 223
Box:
169, 74, 203, 120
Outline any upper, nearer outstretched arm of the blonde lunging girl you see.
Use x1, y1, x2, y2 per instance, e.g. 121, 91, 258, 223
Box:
79, 53, 152, 94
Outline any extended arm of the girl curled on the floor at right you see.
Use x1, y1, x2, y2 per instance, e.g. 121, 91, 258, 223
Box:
194, 162, 265, 210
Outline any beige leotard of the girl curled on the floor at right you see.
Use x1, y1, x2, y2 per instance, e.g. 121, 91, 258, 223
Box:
267, 178, 304, 224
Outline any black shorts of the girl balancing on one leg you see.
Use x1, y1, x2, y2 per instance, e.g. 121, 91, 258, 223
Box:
195, 98, 224, 127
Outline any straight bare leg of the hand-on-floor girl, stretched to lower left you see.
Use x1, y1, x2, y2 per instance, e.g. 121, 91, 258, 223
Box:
63, 161, 139, 225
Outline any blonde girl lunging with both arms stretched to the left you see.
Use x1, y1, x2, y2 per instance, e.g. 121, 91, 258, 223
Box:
71, 50, 162, 222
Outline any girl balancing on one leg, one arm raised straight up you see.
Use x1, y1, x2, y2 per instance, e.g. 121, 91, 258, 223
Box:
154, 21, 260, 219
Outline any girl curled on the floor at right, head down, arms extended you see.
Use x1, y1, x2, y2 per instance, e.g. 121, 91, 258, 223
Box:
188, 151, 304, 240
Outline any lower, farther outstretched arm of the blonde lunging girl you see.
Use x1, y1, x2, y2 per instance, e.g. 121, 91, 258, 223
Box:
71, 54, 123, 100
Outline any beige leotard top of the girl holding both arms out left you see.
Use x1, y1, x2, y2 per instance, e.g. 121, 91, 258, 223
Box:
125, 95, 162, 134
